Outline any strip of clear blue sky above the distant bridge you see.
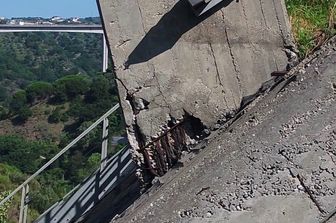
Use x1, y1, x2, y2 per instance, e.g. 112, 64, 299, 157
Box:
0, 0, 99, 18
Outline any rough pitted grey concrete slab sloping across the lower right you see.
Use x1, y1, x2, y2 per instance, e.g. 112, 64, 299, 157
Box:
108, 37, 336, 223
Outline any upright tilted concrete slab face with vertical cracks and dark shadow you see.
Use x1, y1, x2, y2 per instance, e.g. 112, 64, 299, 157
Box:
98, 0, 291, 174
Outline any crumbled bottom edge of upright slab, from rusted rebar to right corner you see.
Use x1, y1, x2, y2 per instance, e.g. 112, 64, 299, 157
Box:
117, 57, 298, 183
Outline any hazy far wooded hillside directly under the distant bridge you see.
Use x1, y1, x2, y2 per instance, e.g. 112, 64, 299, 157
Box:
0, 30, 103, 103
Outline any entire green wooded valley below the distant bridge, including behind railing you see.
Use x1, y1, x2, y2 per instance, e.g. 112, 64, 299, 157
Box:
0, 23, 124, 223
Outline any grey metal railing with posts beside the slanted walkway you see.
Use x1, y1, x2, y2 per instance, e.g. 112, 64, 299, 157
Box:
0, 104, 120, 223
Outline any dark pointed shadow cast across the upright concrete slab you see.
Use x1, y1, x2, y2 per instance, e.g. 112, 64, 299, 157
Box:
124, 0, 233, 69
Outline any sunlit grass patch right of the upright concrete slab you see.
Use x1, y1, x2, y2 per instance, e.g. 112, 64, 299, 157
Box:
286, 0, 336, 57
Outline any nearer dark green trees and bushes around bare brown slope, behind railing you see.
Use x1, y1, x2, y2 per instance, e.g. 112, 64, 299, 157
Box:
0, 74, 124, 220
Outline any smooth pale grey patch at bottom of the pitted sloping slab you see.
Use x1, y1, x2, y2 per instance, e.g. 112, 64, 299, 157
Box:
189, 195, 318, 223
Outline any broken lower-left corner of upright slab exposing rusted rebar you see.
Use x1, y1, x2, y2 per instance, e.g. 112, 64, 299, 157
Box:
116, 69, 218, 179
